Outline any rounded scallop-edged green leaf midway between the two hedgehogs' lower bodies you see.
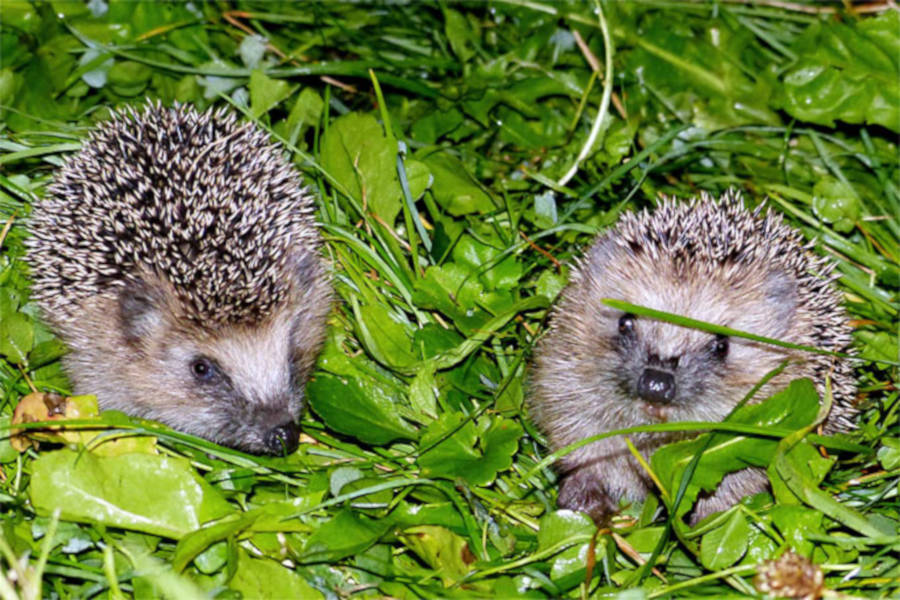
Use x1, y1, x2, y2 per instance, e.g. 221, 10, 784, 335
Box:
418, 413, 523, 485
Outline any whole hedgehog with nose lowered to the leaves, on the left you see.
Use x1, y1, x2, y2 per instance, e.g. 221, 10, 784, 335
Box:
26, 103, 331, 454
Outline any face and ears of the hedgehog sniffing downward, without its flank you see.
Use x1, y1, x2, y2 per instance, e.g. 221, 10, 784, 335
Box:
108, 282, 317, 454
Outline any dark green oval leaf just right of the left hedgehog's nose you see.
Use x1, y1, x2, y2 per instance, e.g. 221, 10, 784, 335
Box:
306, 373, 417, 445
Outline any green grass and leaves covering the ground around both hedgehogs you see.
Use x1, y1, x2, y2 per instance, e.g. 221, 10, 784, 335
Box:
0, 0, 900, 600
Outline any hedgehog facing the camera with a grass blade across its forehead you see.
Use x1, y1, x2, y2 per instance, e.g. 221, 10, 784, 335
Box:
529, 191, 856, 523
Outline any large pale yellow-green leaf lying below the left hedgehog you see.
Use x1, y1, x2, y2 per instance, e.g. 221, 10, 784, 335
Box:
28, 450, 233, 539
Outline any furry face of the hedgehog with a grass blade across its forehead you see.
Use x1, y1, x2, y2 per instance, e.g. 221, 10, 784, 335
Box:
545, 240, 803, 433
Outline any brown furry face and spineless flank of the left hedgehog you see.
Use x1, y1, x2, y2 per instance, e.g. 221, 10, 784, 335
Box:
56, 264, 330, 454
